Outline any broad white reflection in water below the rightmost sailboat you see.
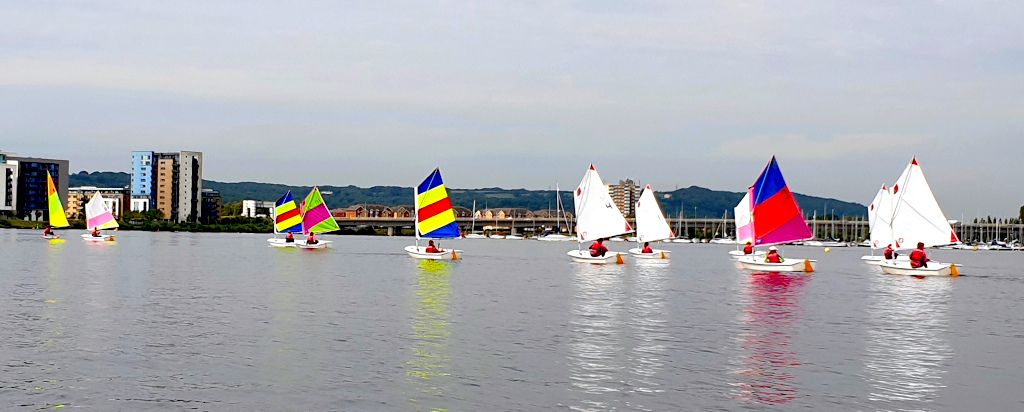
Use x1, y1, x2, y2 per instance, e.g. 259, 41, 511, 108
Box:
864, 276, 955, 410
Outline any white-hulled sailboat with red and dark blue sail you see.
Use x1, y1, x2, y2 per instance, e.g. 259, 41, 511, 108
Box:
738, 156, 817, 272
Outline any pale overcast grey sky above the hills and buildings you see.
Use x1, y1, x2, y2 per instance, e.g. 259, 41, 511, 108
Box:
0, 0, 1024, 219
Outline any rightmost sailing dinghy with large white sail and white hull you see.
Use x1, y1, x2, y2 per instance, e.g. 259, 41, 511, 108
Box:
879, 158, 959, 276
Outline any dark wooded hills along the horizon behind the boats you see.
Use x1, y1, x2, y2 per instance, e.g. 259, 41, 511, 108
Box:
70, 171, 867, 217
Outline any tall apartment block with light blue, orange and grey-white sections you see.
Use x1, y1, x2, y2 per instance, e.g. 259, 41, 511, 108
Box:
131, 152, 203, 222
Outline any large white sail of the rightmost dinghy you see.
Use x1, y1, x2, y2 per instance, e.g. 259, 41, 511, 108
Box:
888, 158, 959, 248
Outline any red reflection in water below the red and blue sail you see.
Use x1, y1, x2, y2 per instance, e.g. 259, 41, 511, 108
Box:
734, 273, 810, 404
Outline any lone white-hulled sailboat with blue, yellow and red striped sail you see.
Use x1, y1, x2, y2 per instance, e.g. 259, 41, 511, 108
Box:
406, 168, 462, 260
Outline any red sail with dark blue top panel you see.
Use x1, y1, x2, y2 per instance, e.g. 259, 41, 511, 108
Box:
751, 156, 814, 245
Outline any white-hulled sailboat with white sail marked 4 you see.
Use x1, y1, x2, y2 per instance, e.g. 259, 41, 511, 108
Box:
567, 165, 633, 263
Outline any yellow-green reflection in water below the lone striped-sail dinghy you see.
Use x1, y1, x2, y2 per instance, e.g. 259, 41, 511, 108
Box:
408, 260, 452, 409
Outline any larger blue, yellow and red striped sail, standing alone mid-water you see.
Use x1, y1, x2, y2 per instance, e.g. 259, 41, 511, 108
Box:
414, 169, 462, 239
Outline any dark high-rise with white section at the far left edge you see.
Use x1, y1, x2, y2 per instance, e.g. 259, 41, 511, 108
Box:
0, 154, 68, 220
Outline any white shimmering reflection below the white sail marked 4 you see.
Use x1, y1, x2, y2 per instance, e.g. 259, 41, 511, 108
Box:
568, 264, 625, 411
